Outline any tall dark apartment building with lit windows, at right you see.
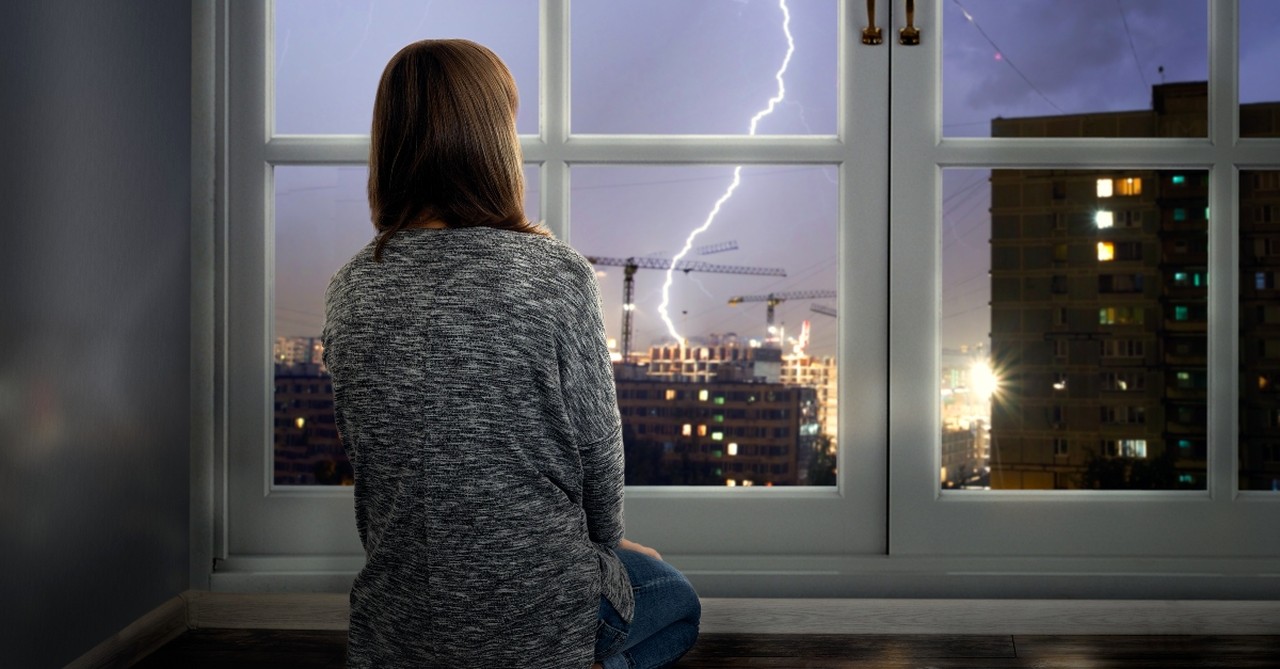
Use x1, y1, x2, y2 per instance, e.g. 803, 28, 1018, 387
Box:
991, 83, 1280, 489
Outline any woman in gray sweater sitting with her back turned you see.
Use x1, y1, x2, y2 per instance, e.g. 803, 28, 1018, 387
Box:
324, 40, 700, 669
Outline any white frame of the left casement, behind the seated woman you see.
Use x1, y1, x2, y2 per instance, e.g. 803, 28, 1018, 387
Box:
214, 0, 888, 590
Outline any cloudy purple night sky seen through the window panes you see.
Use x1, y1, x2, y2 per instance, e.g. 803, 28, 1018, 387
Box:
275, 0, 1280, 354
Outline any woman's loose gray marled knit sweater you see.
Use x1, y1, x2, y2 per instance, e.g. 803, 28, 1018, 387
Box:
324, 228, 634, 669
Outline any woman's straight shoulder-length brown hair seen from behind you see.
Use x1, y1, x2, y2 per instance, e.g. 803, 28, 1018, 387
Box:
369, 40, 550, 261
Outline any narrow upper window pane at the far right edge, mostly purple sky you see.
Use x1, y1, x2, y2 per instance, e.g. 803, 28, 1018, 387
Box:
1240, 0, 1280, 137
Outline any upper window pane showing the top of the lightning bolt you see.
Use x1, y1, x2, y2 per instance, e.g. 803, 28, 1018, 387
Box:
572, 0, 838, 134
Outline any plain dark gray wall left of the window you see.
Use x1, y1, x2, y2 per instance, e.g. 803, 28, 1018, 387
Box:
0, 0, 191, 666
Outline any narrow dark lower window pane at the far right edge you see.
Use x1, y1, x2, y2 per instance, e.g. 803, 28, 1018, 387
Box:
1240, 171, 1280, 490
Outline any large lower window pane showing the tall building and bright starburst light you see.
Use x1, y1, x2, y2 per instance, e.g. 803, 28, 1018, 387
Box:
941, 169, 1208, 490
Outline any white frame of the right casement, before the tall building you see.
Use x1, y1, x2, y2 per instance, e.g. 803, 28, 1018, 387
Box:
890, 0, 1280, 565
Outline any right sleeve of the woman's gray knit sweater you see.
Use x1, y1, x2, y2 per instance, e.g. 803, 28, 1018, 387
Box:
559, 254, 623, 547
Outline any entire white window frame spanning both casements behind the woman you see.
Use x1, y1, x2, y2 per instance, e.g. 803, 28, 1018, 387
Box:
202, 0, 1280, 597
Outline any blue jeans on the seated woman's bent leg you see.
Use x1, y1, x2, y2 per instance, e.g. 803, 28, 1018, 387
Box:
595, 550, 703, 669
